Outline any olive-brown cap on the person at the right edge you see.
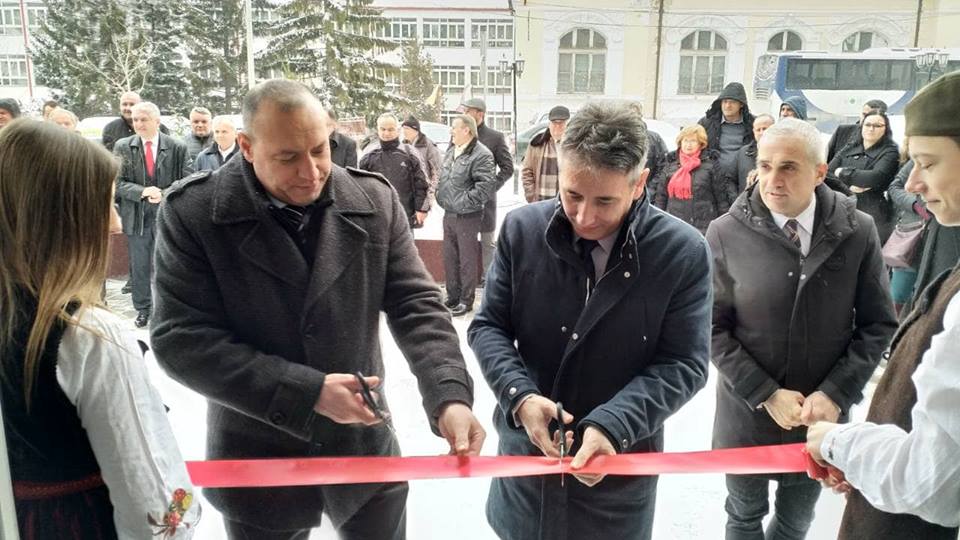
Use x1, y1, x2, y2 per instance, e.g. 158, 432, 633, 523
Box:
904, 71, 960, 137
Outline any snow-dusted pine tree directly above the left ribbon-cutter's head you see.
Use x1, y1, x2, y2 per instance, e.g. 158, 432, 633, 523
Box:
261, 0, 397, 122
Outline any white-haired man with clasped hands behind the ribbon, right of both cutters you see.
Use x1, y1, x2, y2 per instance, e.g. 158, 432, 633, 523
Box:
707, 118, 897, 540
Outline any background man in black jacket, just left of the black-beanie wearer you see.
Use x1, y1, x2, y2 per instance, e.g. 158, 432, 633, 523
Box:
360, 113, 430, 227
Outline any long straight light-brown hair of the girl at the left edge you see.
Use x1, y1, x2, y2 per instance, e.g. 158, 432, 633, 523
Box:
0, 119, 119, 406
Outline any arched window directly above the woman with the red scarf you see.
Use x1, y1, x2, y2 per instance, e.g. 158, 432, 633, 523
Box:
677, 30, 727, 95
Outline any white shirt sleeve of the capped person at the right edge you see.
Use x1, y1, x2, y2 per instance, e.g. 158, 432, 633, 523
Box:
820, 294, 960, 527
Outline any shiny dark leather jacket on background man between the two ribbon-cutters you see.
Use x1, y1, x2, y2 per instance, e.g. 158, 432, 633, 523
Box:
437, 139, 497, 214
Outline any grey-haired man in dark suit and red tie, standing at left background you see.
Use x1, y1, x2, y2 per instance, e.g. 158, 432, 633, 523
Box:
113, 101, 193, 328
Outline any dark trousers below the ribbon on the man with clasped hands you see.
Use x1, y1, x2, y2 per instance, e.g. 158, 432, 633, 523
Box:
726, 474, 823, 540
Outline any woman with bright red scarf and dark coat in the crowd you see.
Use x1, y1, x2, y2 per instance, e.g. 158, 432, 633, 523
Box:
654, 124, 737, 234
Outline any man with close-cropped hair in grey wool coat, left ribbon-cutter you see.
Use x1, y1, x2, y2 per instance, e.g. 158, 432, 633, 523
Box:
151, 80, 485, 540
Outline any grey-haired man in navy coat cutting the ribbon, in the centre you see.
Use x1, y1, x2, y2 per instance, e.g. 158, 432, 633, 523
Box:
468, 103, 712, 540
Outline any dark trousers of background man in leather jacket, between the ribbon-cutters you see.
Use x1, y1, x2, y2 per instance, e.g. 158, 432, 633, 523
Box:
443, 212, 483, 306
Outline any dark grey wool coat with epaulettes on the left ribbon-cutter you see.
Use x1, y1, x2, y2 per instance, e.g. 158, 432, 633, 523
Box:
151, 159, 473, 530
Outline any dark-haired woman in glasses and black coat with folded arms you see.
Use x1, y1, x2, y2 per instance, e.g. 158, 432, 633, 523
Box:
827, 110, 900, 244
